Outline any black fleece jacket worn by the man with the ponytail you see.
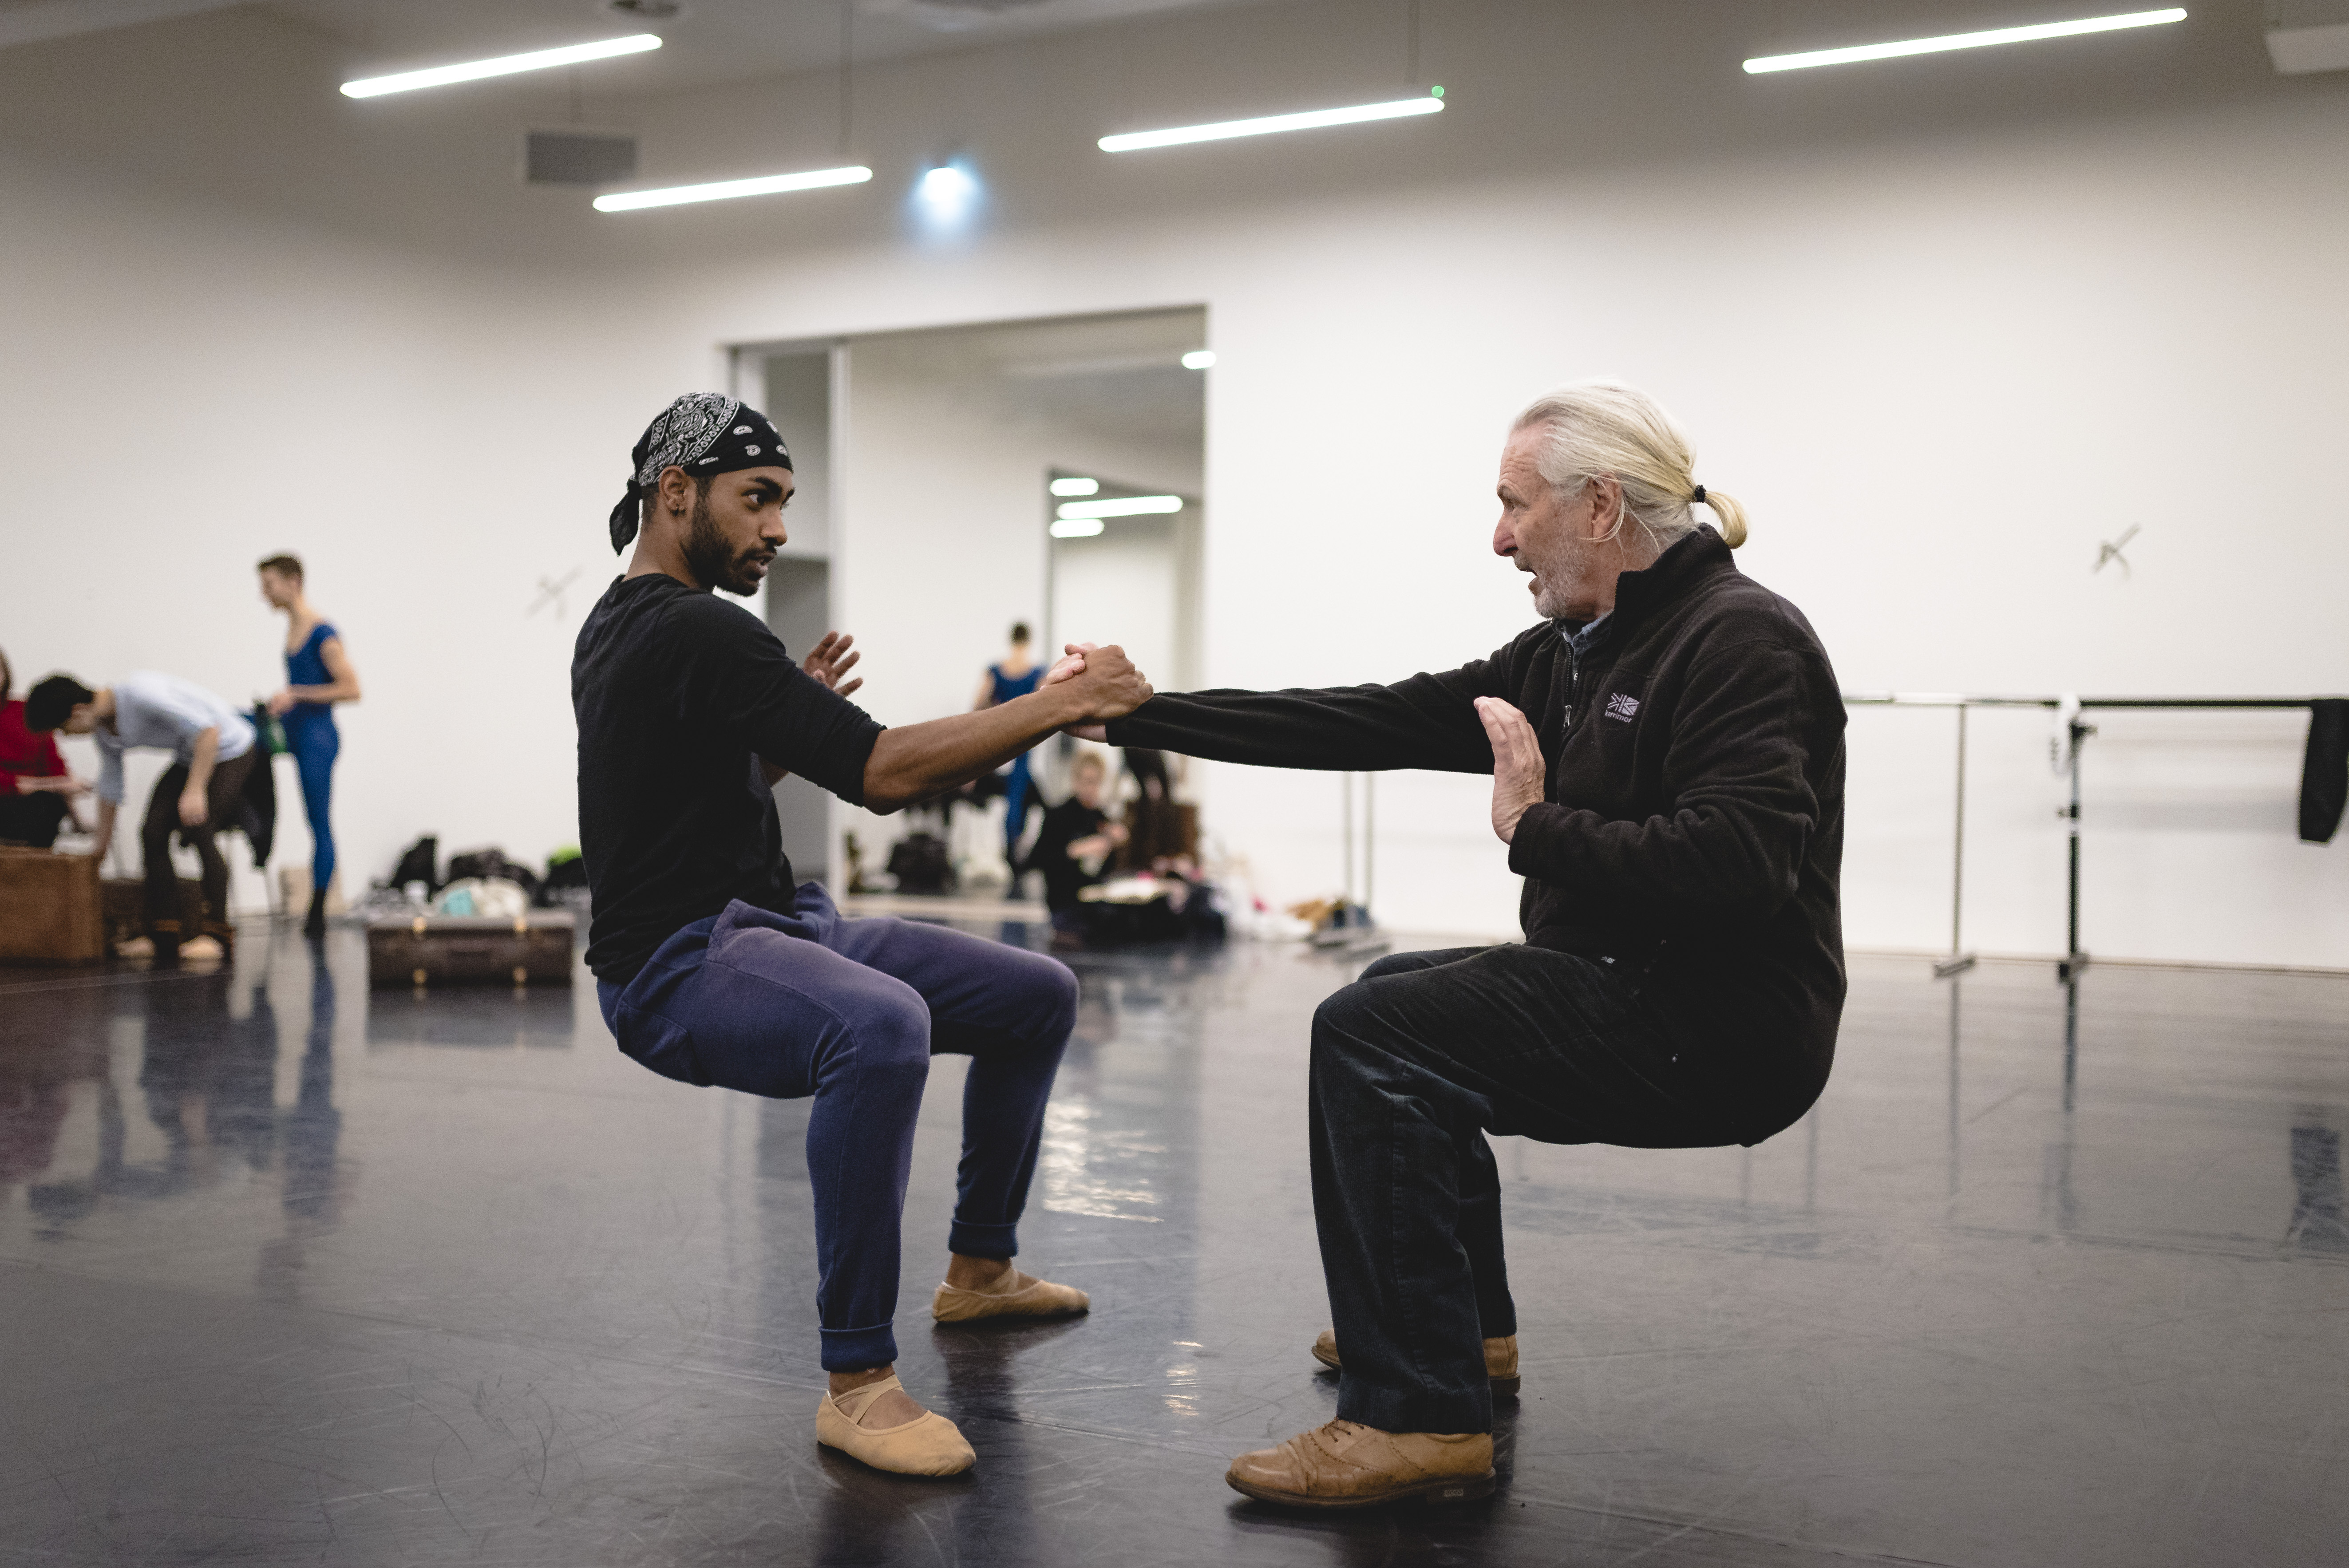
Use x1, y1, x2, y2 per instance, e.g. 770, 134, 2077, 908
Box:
1109, 528, 1844, 1124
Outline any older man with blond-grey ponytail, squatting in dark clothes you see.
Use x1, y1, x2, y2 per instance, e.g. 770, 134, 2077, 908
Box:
1080, 383, 1844, 1507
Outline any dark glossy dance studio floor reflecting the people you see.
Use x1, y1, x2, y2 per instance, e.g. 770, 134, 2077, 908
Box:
0, 927, 2349, 1568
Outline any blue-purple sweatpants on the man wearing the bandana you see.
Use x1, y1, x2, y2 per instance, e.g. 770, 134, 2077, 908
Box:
597, 883, 1076, 1371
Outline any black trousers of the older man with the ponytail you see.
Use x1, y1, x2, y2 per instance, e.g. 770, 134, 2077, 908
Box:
1311, 946, 1740, 1432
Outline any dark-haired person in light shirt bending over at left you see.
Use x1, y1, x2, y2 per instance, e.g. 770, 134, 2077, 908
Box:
24, 671, 261, 960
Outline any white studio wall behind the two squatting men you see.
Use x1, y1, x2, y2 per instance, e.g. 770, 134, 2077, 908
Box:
0, 0, 2349, 965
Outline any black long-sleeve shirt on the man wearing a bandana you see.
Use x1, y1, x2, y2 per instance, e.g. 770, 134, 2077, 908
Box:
571, 573, 881, 986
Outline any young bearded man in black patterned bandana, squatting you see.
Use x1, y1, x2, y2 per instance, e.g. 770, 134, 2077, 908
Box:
571, 392, 1151, 1474
